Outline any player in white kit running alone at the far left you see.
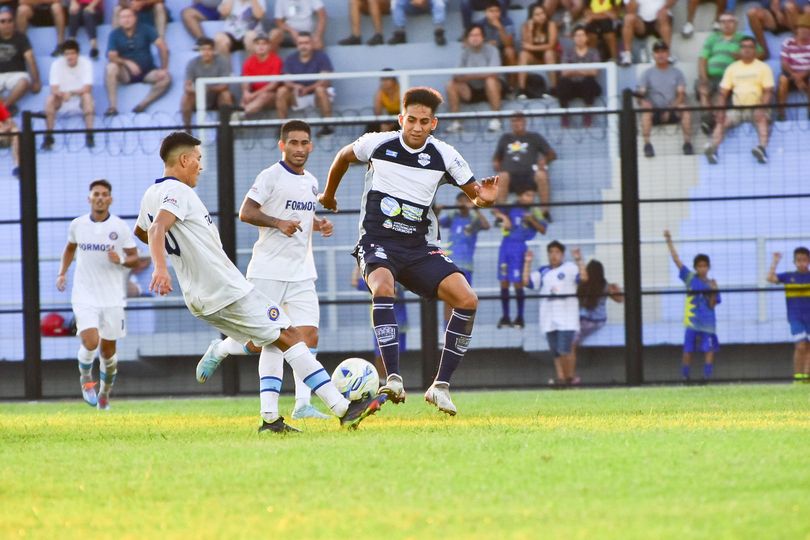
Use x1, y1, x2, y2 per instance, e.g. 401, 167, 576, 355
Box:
56, 180, 138, 410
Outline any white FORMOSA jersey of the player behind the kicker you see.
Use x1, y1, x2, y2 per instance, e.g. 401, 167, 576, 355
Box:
247, 161, 318, 281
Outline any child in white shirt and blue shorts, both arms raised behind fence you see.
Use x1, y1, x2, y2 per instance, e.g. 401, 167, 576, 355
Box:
523, 240, 588, 386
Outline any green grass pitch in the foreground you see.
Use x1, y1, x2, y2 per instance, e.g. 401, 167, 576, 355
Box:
0, 385, 810, 539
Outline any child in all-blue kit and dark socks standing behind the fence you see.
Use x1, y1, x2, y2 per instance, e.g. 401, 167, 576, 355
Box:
494, 188, 548, 328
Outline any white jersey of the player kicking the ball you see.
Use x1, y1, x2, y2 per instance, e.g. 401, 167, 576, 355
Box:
138, 177, 253, 315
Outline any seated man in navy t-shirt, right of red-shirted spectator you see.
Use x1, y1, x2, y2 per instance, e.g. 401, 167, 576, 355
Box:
276, 32, 335, 137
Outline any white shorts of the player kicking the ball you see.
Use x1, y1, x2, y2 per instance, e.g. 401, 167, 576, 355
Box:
197, 289, 292, 347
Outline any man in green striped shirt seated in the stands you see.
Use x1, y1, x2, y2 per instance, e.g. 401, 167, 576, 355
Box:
695, 13, 763, 135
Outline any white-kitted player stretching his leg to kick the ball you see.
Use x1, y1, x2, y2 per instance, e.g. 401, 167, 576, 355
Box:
135, 131, 385, 433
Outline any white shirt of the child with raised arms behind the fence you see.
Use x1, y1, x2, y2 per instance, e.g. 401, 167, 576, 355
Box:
529, 262, 579, 332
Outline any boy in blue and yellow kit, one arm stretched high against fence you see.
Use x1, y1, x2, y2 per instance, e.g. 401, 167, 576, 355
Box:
664, 231, 721, 382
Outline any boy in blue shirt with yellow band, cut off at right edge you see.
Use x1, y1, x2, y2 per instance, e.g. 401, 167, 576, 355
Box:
767, 246, 810, 383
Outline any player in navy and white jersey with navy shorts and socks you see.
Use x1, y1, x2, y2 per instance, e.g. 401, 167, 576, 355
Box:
318, 87, 498, 415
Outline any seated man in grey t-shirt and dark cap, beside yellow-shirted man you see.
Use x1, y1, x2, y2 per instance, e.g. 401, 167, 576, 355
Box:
638, 41, 695, 157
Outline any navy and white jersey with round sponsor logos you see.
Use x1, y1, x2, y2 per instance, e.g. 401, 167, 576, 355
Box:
353, 131, 475, 244
